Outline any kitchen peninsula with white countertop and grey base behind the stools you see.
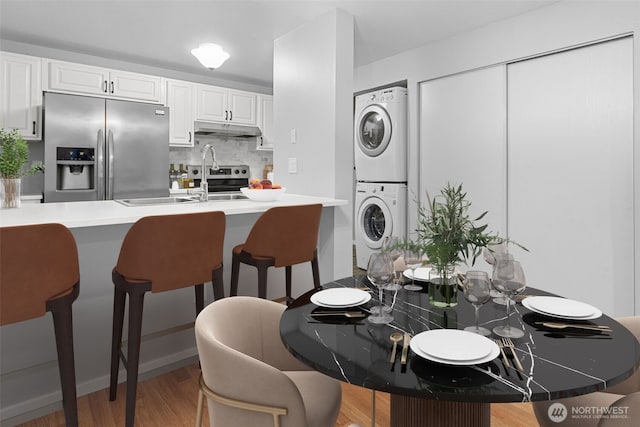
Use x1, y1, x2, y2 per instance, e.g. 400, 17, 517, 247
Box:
0, 194, 348, 421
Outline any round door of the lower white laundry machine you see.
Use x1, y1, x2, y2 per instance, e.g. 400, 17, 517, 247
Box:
358, 197, 393, 249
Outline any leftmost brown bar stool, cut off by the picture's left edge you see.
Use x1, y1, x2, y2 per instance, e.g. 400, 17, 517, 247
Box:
0, 224, 80, 426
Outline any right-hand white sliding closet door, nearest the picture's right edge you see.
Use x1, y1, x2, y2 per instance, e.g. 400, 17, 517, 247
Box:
507, 38, 634, 316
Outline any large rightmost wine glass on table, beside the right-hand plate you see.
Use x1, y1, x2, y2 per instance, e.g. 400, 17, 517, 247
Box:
492, 257, 526, 338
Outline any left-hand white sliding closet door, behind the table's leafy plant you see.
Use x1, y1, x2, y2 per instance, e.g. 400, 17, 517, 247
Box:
422, 65, 506, 269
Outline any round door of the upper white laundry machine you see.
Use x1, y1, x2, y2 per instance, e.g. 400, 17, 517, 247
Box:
356, 105, 392, 157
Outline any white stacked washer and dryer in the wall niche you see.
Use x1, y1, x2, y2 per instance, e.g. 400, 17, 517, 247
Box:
354, 87, 407, 269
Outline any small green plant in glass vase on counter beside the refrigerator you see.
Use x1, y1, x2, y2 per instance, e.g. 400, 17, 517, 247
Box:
0, 129, 44, 208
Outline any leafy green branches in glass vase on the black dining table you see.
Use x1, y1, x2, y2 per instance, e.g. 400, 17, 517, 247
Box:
415, 184, 503, 307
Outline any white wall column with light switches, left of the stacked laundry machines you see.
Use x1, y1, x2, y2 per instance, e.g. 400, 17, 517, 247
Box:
273, 10, 353, 281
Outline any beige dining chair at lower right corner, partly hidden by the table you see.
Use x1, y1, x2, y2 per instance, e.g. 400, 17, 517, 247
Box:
533, 316, 640, 427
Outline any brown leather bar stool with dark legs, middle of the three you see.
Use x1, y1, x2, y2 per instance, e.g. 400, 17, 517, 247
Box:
109, 212, 225, 427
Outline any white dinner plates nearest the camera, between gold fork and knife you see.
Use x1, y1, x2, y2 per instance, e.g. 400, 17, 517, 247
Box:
409, 329, 500, 365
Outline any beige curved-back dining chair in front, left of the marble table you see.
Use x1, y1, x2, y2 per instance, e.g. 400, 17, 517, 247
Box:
195, 296, 342, 427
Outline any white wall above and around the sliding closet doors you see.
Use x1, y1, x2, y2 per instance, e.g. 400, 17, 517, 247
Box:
354, 1, 640, 314
